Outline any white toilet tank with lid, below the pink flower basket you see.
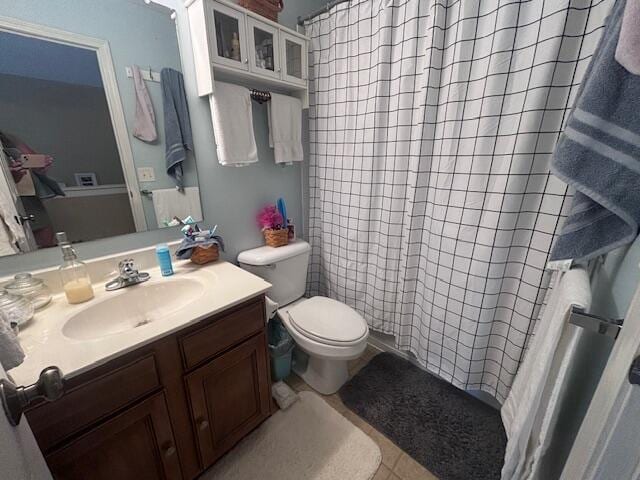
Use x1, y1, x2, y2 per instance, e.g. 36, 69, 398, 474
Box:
238, 240, 311, 306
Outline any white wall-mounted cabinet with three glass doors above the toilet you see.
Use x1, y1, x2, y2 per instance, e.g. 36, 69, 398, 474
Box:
187, 0, 308, 103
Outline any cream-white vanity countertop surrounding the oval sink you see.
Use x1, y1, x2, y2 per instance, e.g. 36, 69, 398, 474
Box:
9, 261, 271, 386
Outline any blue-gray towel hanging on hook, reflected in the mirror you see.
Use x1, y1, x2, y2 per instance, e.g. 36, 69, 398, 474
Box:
160, 68, 193, 190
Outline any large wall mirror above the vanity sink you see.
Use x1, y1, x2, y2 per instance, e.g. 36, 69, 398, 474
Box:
0, 0, 202, 256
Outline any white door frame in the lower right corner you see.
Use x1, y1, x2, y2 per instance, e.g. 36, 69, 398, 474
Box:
561, 276, 640, 480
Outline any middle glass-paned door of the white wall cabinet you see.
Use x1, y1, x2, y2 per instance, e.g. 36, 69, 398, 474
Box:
247, 17, 280, 78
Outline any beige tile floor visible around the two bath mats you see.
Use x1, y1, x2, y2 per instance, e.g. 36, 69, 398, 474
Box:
285, 346, 437, 480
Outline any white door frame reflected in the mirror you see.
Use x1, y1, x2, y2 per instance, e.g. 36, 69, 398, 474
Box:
0, 16, 147, 232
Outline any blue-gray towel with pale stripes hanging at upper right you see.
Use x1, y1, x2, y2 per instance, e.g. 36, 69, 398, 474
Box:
550, 0, 640, 262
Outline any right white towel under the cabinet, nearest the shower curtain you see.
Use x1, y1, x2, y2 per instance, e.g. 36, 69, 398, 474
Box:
267, 93, 303, 163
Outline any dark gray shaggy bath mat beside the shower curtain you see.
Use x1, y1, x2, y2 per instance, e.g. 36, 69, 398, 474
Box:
339, 353, 507, 480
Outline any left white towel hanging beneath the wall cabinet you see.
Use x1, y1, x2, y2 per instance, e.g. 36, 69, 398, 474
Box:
209, 82, 258, 166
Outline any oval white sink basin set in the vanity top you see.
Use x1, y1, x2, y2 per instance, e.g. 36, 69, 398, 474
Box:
62, 278, 205, 340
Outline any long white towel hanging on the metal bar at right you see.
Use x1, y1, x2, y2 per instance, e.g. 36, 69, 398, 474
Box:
500, 268, 591, 480
